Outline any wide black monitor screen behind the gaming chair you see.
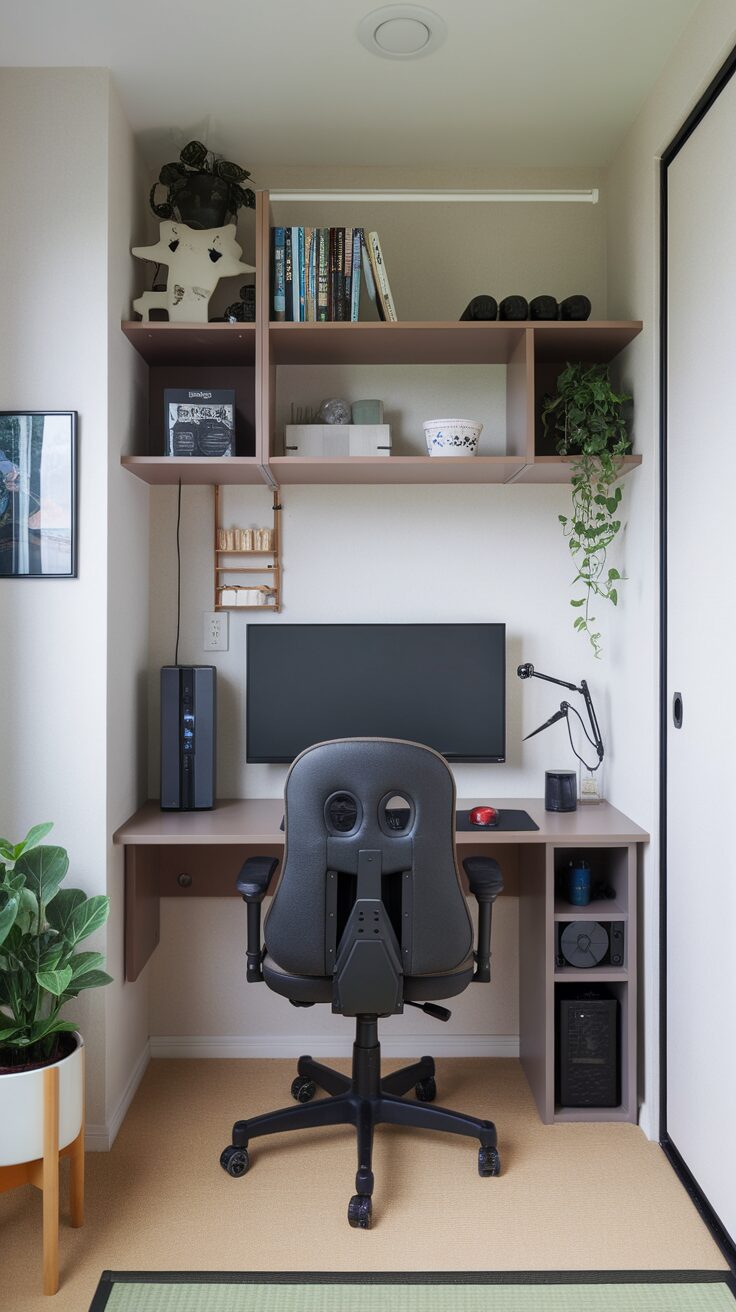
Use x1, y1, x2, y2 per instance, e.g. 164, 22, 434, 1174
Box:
247, 625, 506, 762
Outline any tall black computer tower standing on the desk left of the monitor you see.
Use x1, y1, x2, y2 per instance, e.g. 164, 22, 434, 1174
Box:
161, 665, 216, 811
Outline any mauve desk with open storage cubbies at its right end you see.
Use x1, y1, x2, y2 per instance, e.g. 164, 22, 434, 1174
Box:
113, 798, 649, 1122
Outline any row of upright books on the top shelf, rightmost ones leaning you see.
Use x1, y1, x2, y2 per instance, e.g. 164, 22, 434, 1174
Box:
270, 227, 396, 323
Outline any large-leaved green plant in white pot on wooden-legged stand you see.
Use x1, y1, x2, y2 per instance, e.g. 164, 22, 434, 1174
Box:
0, 824, 110, 1294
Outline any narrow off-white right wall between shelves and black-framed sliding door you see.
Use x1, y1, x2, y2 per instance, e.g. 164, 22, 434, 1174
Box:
606, 0, 736, 1136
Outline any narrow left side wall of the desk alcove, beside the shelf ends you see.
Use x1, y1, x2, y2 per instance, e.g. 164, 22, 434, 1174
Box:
105, 83, 148, 1138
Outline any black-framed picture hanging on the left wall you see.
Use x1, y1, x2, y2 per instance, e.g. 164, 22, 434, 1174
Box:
0, 411, 76, 579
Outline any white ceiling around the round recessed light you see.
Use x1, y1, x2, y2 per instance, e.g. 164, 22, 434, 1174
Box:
0, 0, 697, 168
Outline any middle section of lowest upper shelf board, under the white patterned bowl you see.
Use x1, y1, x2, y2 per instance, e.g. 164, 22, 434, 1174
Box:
269, 455, 523, 484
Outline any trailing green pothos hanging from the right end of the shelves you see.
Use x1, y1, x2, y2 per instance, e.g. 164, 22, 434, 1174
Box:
542, 363, 631, 657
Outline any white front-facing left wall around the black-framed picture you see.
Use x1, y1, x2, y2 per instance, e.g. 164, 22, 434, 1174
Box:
0, 68, 108, 1123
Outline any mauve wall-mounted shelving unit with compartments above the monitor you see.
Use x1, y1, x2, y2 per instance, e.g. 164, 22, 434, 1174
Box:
122, 192, 642, 485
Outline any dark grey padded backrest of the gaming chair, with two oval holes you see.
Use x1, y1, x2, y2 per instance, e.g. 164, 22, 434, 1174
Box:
265, 739, 472, 1012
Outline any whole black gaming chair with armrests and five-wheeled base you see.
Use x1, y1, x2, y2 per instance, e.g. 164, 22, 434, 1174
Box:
220, 739, 502, 1229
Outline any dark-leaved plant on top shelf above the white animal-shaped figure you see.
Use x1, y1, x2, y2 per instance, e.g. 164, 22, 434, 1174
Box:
150, 142, 256, 228
